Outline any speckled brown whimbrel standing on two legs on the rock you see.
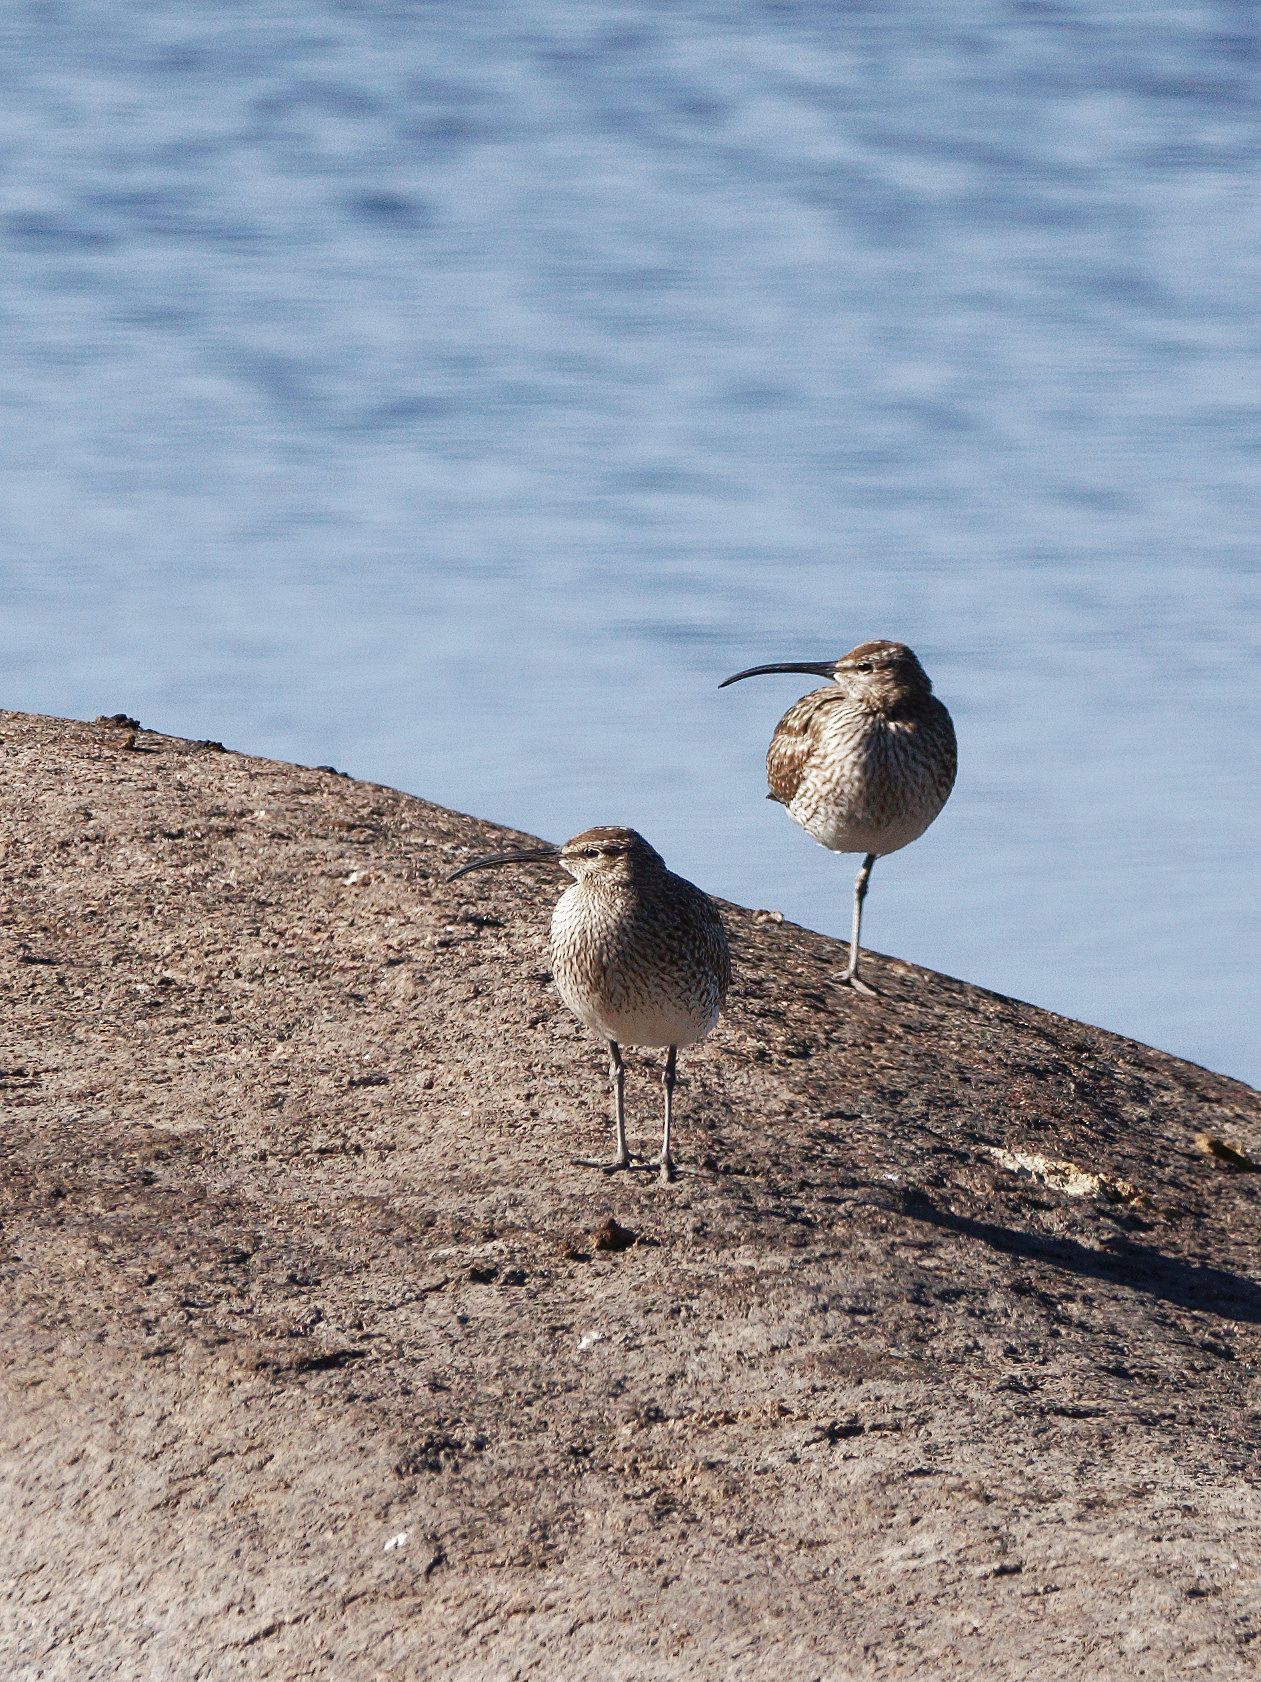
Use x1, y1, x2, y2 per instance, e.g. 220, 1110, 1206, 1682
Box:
447, 828, 731, 1182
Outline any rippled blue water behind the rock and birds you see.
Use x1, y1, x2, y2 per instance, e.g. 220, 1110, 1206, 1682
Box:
0, 0, 1261, 1082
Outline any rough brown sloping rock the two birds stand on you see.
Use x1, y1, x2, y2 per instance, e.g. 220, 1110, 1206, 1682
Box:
0, 713, 1261, 1682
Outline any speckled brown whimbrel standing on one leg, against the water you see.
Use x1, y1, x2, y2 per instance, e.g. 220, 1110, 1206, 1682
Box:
720, 643, 957, 992
